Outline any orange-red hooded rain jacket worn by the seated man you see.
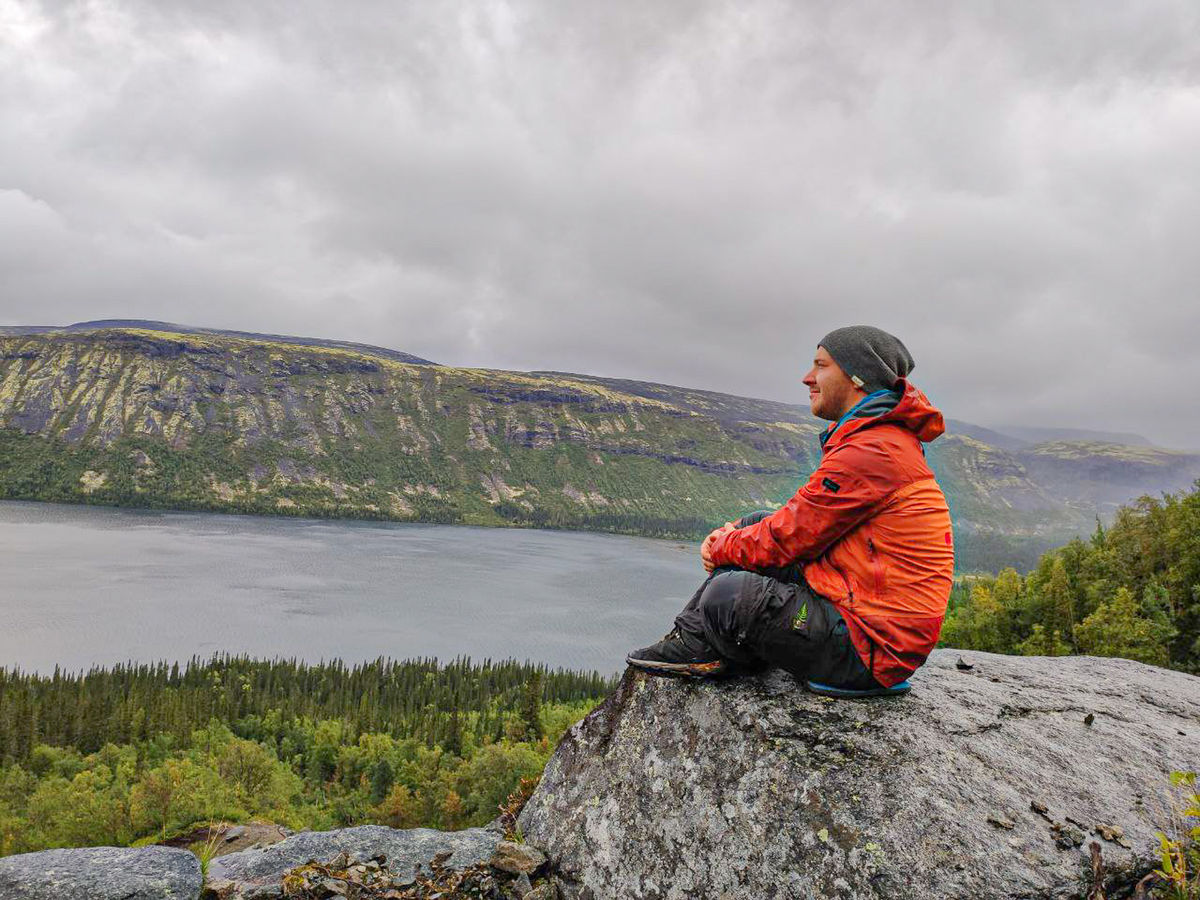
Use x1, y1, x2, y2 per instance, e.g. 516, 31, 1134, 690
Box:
712, 379, 954, 686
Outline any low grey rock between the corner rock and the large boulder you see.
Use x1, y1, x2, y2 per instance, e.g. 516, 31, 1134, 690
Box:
206, 826, 500, 900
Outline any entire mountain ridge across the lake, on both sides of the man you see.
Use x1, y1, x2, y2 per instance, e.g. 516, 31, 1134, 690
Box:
0, 322, 1200, 569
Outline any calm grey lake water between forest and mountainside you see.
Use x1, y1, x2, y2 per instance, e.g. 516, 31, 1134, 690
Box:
0, 502, 704, 673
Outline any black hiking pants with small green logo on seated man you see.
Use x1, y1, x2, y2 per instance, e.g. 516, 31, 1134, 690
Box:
674, 512, 880, 690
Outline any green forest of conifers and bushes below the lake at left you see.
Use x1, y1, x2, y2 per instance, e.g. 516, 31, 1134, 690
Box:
0, 655, 613, 856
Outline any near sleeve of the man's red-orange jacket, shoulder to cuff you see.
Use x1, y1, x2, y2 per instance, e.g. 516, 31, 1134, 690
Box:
712, 442, 900, 569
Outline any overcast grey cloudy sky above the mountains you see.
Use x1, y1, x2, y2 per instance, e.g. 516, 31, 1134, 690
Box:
0, 0, 1200, 448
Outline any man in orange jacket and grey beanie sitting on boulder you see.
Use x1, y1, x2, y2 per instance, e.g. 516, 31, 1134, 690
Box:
626, 325, 954, 694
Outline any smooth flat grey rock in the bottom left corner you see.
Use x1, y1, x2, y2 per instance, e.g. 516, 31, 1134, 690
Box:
0, 847, 203, 900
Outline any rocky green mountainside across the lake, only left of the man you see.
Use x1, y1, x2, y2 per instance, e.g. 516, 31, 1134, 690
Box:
0, 329, 817, 535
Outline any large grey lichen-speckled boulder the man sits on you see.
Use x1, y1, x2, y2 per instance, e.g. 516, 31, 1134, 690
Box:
518, 650, 1200, 900
